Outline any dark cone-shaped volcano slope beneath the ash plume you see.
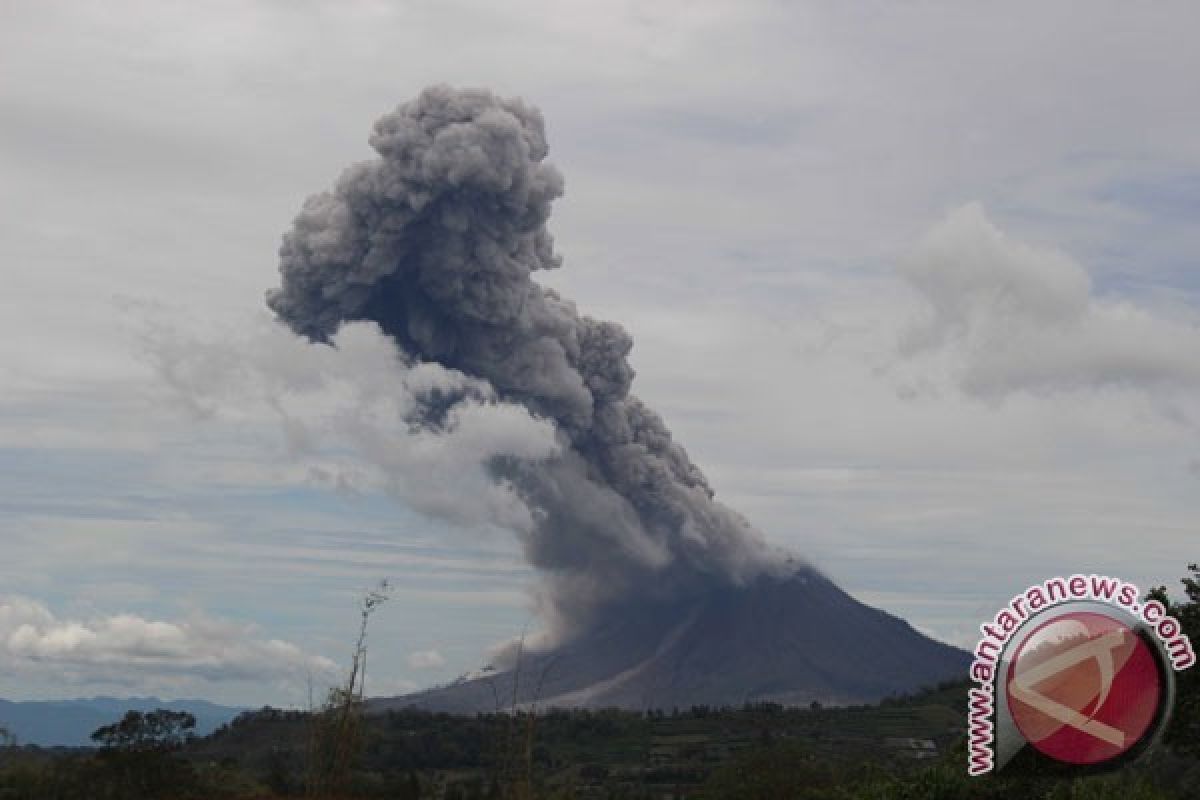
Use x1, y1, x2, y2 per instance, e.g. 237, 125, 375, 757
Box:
379, 569, 968, 714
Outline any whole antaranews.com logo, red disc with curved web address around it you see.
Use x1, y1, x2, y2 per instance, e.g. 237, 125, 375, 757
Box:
967, 575, 1195, 775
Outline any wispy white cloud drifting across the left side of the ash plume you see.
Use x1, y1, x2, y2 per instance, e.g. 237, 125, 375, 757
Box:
144, 318, 558, 531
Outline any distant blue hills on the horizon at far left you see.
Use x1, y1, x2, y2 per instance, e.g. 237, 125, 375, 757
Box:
0, 697, 245, 747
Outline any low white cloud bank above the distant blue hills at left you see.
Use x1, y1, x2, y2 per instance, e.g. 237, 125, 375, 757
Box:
0, 596, 335, 684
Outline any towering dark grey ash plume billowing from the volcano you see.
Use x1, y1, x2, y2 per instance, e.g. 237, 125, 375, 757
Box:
268, 86, 780, 633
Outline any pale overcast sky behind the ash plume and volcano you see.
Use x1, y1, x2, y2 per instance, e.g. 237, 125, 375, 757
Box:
0, 0, 1200, 705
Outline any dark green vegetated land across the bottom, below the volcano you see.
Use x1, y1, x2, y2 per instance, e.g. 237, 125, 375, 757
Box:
0, 566, 1200, 800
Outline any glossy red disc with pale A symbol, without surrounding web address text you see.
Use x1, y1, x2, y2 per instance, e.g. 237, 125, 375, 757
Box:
1006, 612, 1164, 764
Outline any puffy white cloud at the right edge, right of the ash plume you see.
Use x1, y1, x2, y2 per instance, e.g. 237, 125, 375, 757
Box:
901, 204, 1200, 397
